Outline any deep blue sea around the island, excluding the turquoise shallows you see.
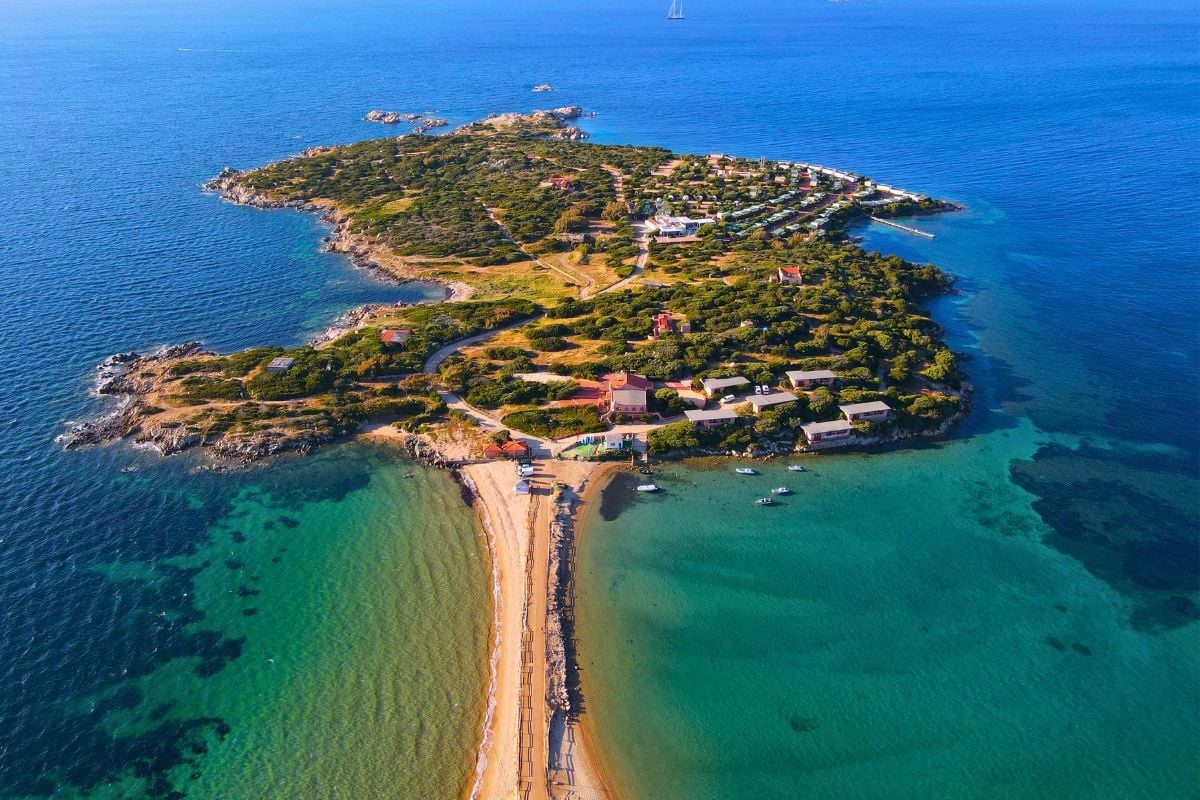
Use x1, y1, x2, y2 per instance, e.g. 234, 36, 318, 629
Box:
0, 0, 1200, 798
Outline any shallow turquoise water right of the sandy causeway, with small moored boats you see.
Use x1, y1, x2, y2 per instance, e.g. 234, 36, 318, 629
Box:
577, 425, 1200, 800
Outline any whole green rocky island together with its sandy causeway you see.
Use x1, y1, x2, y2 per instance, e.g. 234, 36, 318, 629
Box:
62, 107, 970, 798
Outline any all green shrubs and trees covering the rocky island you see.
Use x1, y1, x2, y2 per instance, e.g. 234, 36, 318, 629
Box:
163, 118, 964, 455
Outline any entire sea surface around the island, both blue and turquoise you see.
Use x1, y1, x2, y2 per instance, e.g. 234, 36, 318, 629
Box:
0, 0, 1200, 800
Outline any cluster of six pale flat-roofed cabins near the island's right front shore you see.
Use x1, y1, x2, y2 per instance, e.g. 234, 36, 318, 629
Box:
684, 369, 892, 447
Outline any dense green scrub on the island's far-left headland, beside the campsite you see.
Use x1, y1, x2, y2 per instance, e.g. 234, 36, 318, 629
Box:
242, 128, 670, 266
